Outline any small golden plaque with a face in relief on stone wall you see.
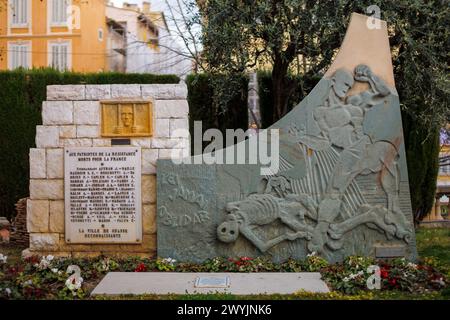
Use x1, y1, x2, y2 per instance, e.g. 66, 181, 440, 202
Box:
101, 101, 153, 137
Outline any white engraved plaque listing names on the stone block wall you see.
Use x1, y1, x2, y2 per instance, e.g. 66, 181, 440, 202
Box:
64, 147, 142, 243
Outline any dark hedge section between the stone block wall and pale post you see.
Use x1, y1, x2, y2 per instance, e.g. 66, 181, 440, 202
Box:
186, 74, 248, 153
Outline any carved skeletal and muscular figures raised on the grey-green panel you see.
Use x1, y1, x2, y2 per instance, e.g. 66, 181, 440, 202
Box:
217, 65, 413, 253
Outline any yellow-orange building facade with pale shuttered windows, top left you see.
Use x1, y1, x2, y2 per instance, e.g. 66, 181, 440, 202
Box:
0, 0, 108, 72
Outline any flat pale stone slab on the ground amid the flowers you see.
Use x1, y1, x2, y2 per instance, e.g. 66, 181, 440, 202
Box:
91, 272, 329, 295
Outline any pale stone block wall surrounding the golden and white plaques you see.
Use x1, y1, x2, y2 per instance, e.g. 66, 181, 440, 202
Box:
27, 84, 190, 257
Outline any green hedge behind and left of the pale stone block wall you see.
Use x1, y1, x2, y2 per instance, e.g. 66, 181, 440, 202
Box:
0, 69, 179, 217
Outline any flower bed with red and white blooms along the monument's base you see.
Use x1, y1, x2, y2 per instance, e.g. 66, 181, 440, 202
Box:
0, 254, 449, 299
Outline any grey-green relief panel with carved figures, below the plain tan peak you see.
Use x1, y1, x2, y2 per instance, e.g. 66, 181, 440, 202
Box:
157, 13, 417, 262
